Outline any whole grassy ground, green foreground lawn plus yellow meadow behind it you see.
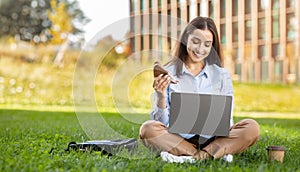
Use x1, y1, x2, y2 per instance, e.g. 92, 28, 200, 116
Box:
0, 52, 300, 171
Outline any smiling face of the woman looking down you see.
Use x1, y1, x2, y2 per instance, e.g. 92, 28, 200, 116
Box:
187, 29, 213, 63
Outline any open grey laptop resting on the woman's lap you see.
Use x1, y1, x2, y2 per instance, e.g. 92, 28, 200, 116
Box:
169, 92, 232, 136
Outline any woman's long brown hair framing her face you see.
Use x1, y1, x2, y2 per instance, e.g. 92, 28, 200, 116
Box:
167, 17, 223, 75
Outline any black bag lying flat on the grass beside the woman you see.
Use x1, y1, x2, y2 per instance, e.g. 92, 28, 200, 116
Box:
66, 138, 138, 156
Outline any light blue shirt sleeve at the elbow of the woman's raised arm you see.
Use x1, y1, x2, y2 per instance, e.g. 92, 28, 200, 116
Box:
151, 92, 170, 125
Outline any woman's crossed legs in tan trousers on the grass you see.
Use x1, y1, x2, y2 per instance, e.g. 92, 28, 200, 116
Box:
140, 119, 260, 159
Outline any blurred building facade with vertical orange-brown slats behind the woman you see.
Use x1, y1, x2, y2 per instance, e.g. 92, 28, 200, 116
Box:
129, 0, 300, 83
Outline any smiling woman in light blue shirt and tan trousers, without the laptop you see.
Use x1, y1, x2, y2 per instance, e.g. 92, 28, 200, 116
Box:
140, 17, 260, 160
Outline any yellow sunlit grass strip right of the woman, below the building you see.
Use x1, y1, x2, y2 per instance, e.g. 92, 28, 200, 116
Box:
234, 83, 300, 114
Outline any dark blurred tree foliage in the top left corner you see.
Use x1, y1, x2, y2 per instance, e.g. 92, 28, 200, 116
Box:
0, 0, 51, 41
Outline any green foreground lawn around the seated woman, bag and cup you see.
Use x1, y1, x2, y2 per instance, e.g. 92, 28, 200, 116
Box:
0, 109, 300, 171
